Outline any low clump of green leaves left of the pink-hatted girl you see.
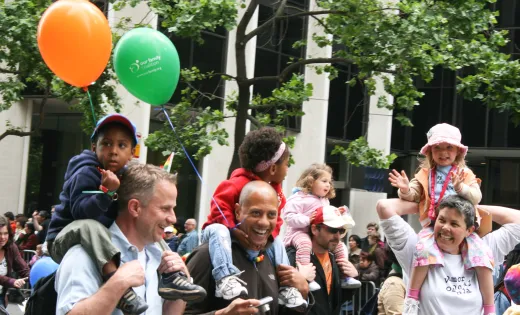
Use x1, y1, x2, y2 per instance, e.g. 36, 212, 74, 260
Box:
332, 137, 397, 169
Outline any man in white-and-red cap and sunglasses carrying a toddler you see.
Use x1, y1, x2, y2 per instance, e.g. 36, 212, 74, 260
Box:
287, 207, 358, 315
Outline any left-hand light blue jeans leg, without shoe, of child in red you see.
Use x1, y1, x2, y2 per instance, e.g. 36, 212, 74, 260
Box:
202, 223, 240, 281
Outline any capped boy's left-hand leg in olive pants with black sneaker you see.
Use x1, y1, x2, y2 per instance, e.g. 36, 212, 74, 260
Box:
51, 219, 148, 314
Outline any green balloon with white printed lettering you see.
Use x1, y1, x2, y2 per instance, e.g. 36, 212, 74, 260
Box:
114, 28, 181, 106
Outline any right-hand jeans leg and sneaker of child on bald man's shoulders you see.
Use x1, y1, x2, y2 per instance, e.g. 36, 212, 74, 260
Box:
266, 237, 307, 311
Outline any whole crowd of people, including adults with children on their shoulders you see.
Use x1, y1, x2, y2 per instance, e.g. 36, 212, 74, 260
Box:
0, 114, 520, 315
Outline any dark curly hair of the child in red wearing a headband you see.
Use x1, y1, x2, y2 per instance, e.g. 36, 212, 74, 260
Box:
238, 127, 289, 172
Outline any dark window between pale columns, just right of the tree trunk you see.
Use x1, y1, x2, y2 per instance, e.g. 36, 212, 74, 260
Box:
253, 0, 307, 131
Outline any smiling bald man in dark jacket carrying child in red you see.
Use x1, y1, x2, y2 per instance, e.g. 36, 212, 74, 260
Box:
184, 181, 314, 315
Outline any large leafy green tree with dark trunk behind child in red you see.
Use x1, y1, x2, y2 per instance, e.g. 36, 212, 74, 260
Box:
147, 0, 520, 175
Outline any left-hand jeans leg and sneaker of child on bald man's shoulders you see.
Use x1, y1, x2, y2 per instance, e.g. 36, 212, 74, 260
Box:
202, 223, 247, 300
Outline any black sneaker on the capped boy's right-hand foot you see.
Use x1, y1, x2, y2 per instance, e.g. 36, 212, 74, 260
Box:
159, 272, 206, 302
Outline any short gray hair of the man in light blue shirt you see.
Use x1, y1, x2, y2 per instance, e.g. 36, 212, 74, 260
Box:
117, 164, 177, 211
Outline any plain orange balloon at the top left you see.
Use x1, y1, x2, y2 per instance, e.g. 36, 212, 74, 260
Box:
37, 0, 112, 87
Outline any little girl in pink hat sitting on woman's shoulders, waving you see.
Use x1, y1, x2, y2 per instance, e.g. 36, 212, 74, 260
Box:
389, 123, 495, 315
